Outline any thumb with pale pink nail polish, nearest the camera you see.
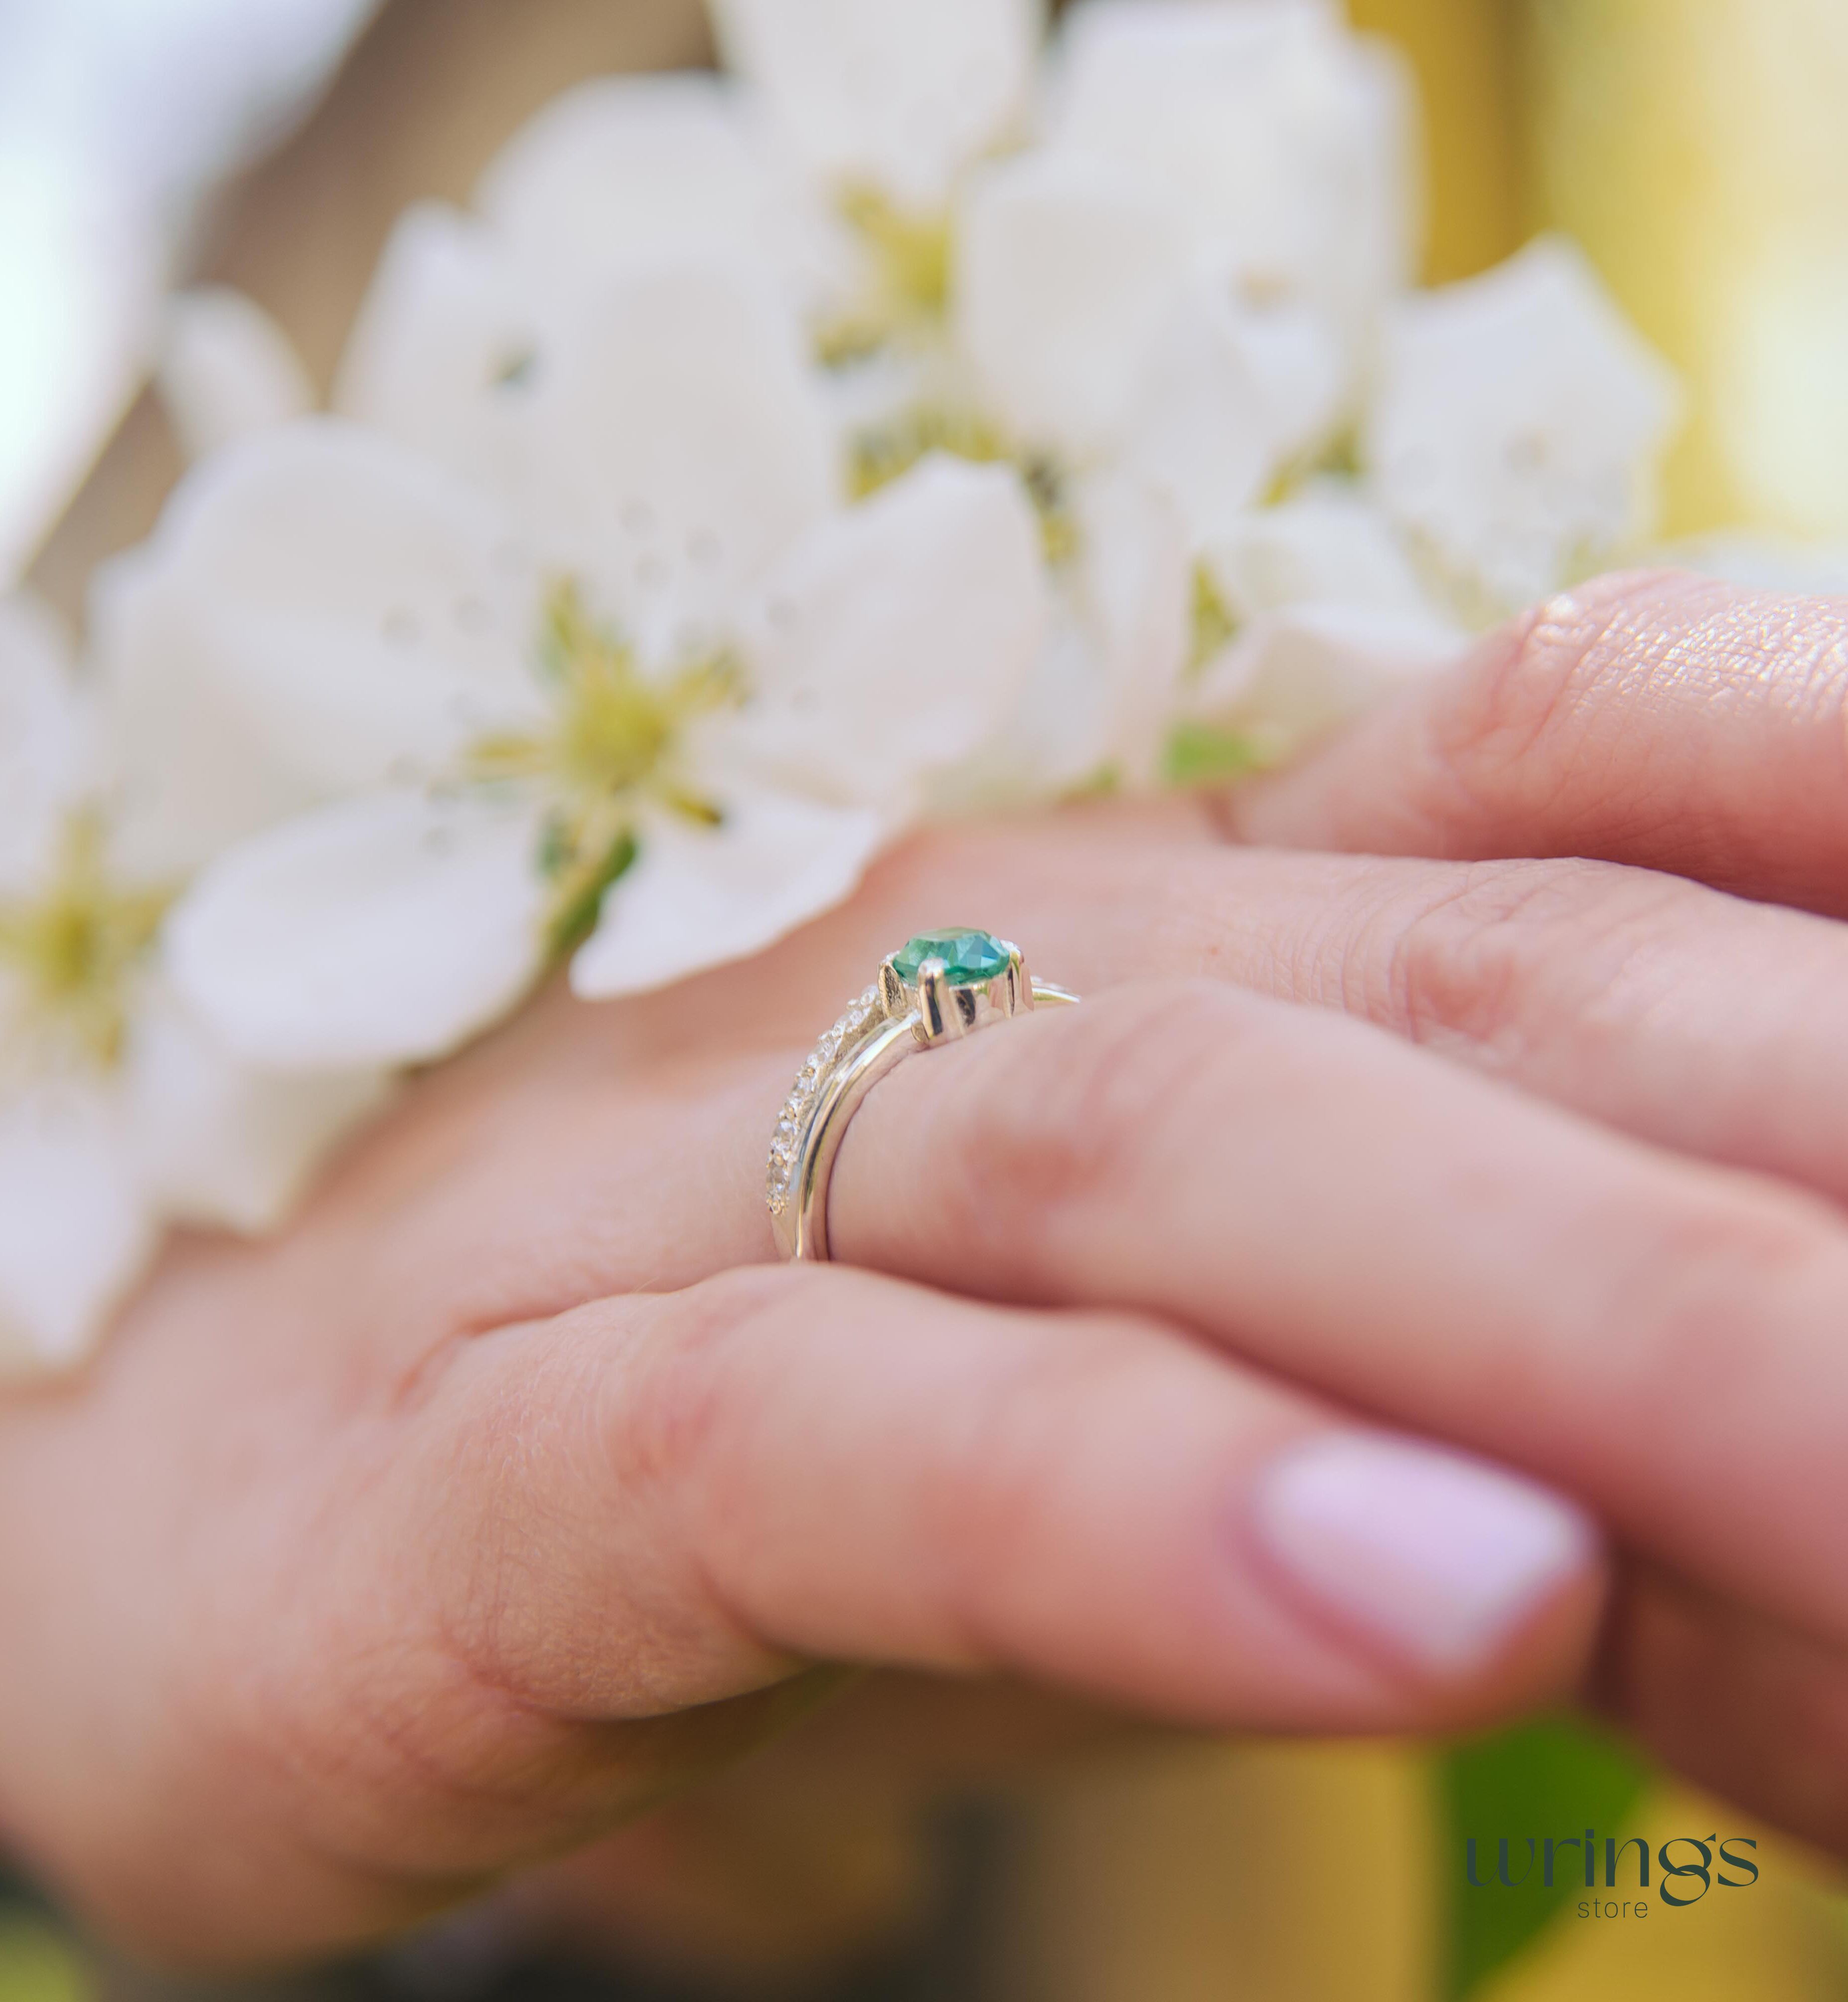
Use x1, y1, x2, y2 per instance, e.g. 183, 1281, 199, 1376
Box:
407, 1267, 1590, 1730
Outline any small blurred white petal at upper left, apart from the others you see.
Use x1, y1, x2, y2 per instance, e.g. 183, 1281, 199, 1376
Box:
158, 284, 314, 459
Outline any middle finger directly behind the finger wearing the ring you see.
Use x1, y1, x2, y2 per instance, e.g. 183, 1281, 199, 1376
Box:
861, 821, 1848, 1201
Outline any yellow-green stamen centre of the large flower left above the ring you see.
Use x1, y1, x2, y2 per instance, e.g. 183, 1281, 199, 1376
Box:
466, 581, 743, 955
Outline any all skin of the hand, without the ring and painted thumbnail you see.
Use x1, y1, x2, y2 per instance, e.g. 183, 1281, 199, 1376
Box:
0, 579, 1848, 1968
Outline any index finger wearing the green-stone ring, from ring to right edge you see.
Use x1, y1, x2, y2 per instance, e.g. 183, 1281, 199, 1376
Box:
831, 983, 1848, 1640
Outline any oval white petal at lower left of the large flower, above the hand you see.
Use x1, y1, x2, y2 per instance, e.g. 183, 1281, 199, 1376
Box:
166, 791, 545, 1071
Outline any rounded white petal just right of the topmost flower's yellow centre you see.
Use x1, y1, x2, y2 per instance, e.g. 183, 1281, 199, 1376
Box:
955, 154, 1187, 459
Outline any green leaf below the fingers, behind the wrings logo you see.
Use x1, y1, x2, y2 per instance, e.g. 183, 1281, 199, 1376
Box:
1437, 1718, 1650, 2002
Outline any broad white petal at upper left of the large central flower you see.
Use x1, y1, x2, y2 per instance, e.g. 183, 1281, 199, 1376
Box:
92, 418, 543, 875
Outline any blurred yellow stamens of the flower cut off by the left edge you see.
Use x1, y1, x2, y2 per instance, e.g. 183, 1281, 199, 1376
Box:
0, 813, 172, 1069
